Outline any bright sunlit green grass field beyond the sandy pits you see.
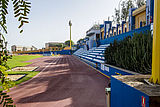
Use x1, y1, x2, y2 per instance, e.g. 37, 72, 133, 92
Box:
7, 55, 43, 68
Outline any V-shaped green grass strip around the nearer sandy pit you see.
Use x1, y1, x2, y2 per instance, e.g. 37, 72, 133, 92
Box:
7, 71, 39, 85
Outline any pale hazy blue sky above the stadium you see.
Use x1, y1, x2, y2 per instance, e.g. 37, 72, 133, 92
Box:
6, 0, 120, 49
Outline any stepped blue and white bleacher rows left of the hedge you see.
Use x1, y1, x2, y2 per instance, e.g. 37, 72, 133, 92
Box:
73, 44, 109, 63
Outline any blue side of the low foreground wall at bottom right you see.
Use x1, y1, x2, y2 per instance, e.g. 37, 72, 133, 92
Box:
111, 77, 149, 107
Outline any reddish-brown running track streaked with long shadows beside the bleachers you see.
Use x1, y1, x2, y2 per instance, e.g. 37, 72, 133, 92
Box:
9, 56, 108, 107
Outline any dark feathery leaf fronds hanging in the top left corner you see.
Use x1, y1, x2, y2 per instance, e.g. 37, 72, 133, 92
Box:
0, 0, 31, 34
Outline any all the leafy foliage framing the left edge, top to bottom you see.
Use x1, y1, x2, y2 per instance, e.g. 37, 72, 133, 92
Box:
0, 0, 31, 107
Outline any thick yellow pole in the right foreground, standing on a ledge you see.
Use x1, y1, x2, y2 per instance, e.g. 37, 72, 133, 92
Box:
150, 0, 160, 84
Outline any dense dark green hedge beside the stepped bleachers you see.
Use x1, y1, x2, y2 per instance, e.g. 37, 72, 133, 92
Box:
105, 32, 152, 74
